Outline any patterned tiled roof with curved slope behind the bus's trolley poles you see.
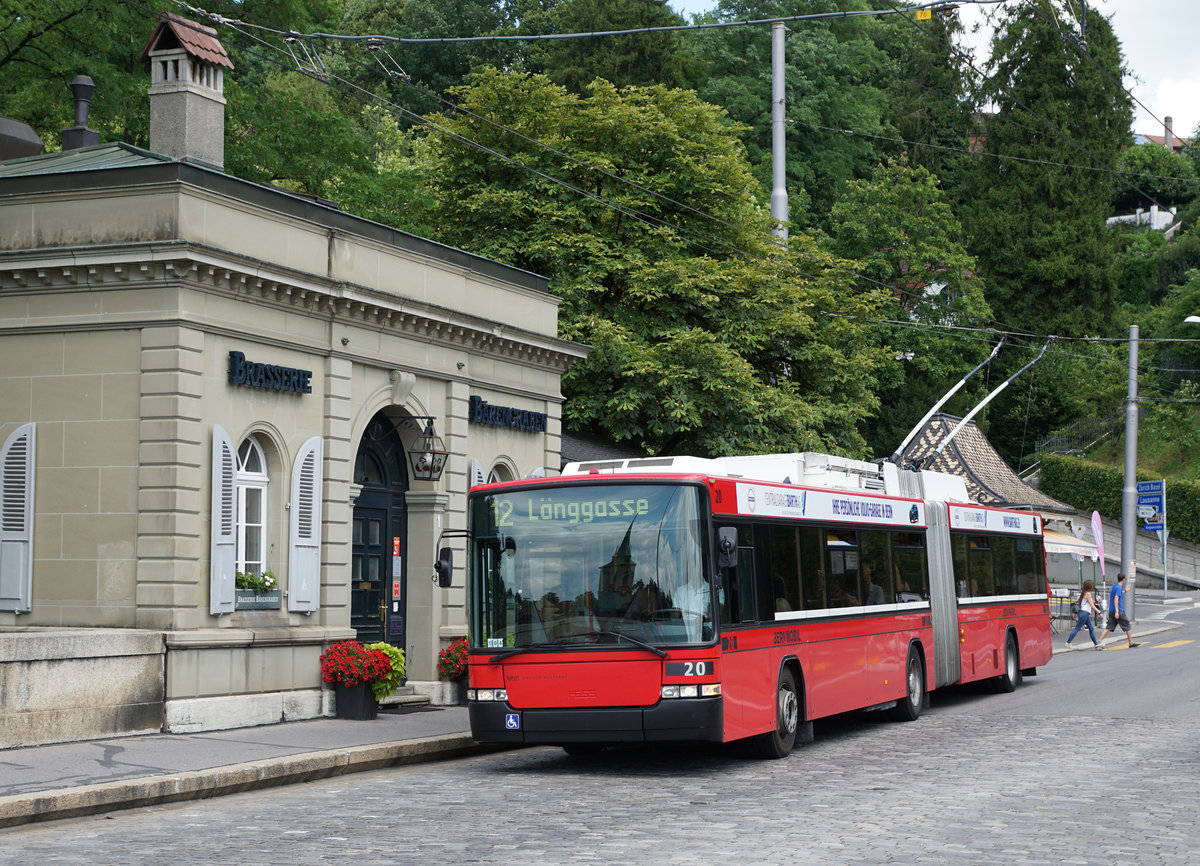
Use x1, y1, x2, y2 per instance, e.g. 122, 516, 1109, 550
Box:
901, 414, 1075, 515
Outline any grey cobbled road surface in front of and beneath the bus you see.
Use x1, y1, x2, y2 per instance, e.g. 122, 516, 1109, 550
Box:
0, 611, 1200, 866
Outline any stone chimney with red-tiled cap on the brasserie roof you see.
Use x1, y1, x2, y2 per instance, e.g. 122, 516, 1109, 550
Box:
142, 13, 233, 169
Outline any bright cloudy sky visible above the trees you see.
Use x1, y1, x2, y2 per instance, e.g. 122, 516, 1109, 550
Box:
667, 0, 1200, 136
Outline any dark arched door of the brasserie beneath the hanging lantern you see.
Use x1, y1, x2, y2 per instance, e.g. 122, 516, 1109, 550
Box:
350, 411, 408, 648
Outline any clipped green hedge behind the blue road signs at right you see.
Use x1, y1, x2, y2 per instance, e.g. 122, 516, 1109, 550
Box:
1039, 455, 1200, 543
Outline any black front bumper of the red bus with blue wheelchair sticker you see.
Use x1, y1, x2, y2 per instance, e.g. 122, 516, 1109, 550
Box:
469, 697, 725, 746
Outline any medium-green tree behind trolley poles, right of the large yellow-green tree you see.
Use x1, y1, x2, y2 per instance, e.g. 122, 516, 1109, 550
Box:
830, 160, 991, 456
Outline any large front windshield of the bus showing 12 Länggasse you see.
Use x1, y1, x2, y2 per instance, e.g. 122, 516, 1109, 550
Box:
468, 483, 714, 649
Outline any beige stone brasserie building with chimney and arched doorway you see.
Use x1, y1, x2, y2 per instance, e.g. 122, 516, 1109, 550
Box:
0, 18, 584, 746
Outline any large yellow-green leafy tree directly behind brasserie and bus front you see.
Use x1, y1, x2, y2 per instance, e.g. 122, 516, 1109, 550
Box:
418, 71, 880, 456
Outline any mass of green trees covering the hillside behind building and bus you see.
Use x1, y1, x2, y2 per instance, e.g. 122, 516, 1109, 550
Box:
0, 0, 1200, 472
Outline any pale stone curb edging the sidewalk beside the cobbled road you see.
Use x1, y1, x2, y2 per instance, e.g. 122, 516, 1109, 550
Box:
0, 733, 508, 828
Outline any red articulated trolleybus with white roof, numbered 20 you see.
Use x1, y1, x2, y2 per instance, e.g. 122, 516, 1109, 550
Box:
438, 453, 1051, 758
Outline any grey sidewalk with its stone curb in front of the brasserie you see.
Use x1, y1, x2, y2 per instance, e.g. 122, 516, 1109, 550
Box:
0, 706, 496, 828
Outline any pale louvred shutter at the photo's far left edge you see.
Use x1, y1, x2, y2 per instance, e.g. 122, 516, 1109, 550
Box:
0, 423, 36, 611
